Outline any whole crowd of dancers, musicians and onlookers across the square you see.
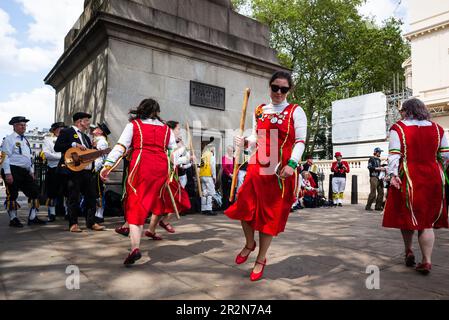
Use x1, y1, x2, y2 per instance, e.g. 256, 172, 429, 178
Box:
1, 71, 449, 281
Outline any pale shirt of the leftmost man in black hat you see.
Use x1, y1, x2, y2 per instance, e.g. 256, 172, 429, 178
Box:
2, 132, 34, 174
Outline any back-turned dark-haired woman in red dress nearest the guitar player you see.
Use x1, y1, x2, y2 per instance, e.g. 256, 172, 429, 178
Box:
100, 99, 176, 265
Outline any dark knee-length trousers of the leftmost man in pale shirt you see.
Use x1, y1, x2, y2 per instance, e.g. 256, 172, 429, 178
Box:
2, 166, 40, 208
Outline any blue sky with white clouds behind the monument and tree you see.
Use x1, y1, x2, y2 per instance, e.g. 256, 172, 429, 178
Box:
0, 0, 408, 138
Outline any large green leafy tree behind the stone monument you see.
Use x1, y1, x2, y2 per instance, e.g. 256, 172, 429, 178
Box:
233, 0, 410, 158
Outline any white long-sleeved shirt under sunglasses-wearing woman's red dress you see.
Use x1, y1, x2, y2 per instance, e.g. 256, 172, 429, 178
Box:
247, 100, 307, 163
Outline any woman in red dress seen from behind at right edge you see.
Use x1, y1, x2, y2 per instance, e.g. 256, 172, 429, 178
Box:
383, 99, 449, 274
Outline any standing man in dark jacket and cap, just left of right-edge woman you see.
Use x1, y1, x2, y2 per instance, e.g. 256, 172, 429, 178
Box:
365, 148, 385, 211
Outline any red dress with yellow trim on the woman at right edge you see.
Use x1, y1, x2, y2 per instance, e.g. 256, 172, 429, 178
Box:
383, 121, 448, 230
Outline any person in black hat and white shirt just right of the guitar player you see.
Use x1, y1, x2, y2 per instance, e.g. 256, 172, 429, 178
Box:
92, 123, 111, 223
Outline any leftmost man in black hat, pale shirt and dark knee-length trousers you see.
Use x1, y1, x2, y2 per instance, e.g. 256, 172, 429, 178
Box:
1, 116, 45, 228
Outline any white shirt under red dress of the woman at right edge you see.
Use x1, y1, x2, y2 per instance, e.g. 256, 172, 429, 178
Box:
388, 119, 449, 176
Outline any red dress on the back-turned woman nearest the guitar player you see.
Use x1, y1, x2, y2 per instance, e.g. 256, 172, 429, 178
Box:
124, 119, 171, 225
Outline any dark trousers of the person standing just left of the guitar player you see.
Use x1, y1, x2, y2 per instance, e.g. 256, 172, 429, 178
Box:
45, 167, 66, 215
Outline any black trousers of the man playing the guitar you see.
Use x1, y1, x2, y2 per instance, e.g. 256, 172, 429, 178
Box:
67, 170, 96, 228
